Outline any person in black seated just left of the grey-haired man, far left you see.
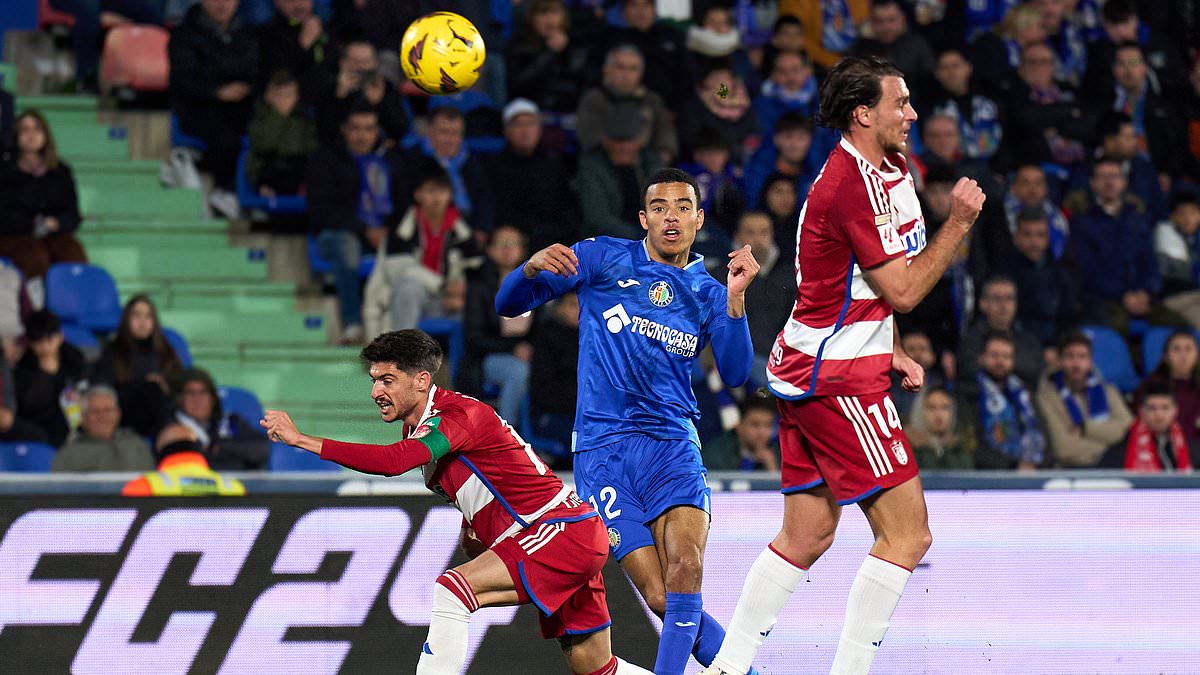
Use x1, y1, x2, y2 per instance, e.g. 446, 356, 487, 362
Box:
14, 310, 86, 447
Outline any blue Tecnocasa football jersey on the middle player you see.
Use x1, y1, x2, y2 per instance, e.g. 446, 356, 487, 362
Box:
497, 237, 752, 452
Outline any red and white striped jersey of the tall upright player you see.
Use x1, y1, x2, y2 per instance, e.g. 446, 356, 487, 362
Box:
767, 138, 925, 399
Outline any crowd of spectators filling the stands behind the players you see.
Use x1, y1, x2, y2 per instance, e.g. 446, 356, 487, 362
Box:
7, 0, 1200, 471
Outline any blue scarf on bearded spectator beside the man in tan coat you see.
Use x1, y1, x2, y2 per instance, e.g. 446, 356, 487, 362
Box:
976, 370, 1046, 465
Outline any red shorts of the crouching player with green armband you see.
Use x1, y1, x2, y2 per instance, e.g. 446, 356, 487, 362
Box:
492, 512, 612, 639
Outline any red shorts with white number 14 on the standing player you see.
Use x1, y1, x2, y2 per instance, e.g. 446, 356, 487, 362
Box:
779, 392, 917, 504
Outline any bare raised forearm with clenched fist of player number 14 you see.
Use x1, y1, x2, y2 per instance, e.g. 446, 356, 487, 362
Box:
865, 178, 985, 313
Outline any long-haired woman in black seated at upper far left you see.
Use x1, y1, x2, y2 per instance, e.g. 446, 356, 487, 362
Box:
0, 110, 88, 282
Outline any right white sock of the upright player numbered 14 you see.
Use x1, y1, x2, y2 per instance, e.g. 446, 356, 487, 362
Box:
829, 555, 912, 675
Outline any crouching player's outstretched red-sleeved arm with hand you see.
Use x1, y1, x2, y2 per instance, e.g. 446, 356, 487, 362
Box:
258, 410, 436, 476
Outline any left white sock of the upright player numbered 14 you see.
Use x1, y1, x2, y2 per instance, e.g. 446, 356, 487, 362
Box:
713, 546, 808, 675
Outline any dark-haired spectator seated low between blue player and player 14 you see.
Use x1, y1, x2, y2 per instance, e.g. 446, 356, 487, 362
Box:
701, 396, 779, 472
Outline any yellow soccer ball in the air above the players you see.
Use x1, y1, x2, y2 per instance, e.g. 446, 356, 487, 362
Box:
400, 12, 486, 95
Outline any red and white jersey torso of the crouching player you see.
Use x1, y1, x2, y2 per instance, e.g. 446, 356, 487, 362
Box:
404, 387, 595, 546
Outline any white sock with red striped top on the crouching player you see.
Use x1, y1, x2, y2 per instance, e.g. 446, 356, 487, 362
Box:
416, 569, 479, 675
